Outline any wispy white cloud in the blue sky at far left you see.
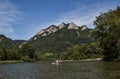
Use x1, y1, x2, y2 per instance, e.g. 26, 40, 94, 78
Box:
0, 0, 22, 36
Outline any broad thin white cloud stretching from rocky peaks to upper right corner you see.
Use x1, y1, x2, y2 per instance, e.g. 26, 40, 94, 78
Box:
43, 1, 120, 28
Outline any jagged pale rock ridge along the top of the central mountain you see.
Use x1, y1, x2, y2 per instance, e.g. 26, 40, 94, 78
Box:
29, 22, 88, 40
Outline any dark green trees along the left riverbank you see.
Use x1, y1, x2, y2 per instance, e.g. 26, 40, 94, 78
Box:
0, 44, 37, 61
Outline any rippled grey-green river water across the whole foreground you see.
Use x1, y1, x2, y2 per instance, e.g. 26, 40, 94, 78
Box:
0, 61, 120, 79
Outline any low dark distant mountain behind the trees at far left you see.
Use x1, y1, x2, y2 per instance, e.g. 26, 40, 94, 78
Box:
0, 34, 25, 49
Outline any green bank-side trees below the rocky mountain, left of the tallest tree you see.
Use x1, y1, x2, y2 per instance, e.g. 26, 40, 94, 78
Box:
40, 42, 103, 60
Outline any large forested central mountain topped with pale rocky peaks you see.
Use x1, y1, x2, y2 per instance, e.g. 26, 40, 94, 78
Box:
27, 22, 93, 54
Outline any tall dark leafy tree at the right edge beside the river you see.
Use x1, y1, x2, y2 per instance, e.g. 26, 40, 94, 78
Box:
94, 7, 120, 61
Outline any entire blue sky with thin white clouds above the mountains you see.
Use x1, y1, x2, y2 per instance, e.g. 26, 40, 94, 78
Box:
0, 0, 120, 40
